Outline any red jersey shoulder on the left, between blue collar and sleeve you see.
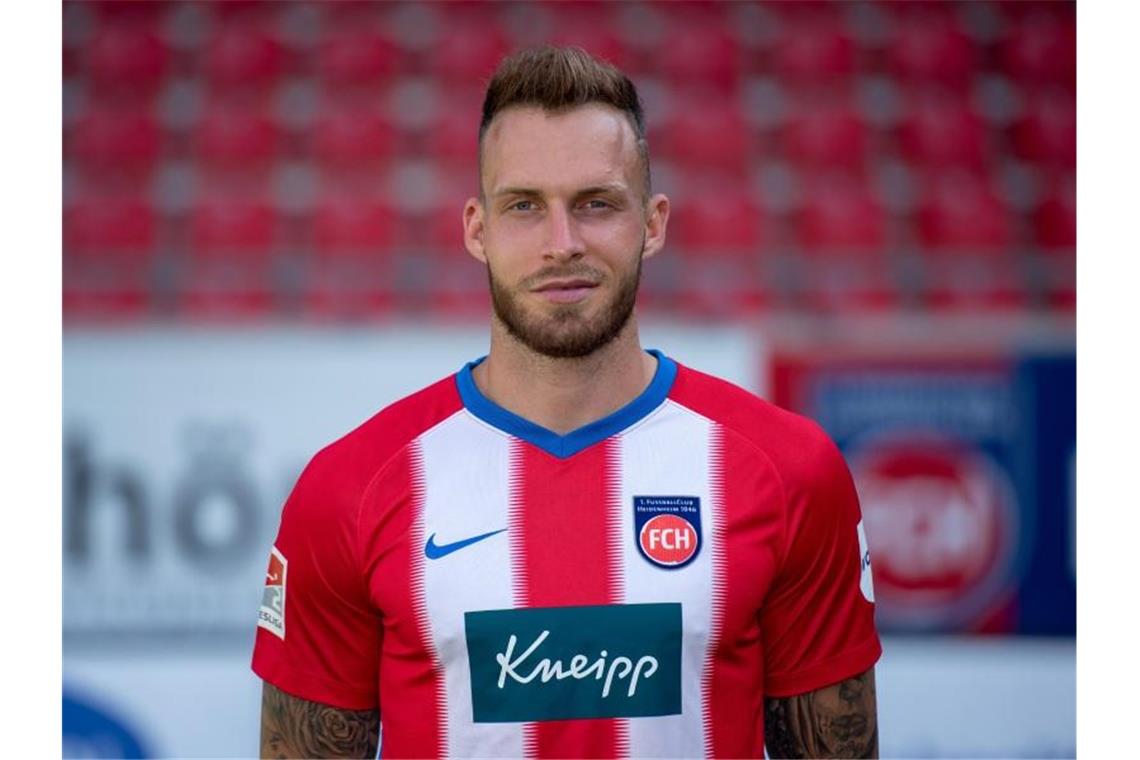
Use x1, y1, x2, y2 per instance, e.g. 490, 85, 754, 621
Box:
295, 375, 463, 517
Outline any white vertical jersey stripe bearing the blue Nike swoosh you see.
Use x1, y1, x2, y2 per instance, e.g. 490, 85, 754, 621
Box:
415, 412, 523, 757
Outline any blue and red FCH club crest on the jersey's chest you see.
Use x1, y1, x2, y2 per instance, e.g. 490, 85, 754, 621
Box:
634, 496, 701, 570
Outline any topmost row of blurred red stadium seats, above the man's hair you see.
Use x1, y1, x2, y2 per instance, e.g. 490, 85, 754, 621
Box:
64, 0, 1076, 97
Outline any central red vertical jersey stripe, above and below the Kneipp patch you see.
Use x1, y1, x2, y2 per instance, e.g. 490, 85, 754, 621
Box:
510, 440, 626, 758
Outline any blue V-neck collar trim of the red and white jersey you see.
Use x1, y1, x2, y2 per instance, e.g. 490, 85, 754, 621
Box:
456, 349, 677, 459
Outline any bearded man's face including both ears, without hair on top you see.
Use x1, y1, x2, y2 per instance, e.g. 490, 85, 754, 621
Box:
464, 105, 668, 358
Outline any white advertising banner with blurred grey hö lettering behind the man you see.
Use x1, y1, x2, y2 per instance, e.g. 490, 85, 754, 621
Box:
64, 325, 760, 647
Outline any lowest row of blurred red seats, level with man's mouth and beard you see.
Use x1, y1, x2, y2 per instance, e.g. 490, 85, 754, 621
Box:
64, 250, 1076, 325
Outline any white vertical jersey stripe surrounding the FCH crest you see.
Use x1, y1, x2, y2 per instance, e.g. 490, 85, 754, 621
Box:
619, 402, 722, 758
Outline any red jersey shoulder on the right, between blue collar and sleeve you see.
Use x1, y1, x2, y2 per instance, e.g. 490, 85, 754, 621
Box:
669, 365, 846, 485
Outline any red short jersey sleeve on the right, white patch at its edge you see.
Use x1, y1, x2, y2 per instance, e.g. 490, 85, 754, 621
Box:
760, 424, 882, 696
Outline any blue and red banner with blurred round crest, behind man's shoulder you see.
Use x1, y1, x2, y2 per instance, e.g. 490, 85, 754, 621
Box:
771, 352, 1076, 636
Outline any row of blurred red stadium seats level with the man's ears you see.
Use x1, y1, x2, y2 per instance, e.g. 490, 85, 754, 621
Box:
64, 173, 1076, 259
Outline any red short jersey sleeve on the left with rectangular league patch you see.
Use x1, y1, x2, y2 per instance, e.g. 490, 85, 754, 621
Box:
253, 450, 382, 710
